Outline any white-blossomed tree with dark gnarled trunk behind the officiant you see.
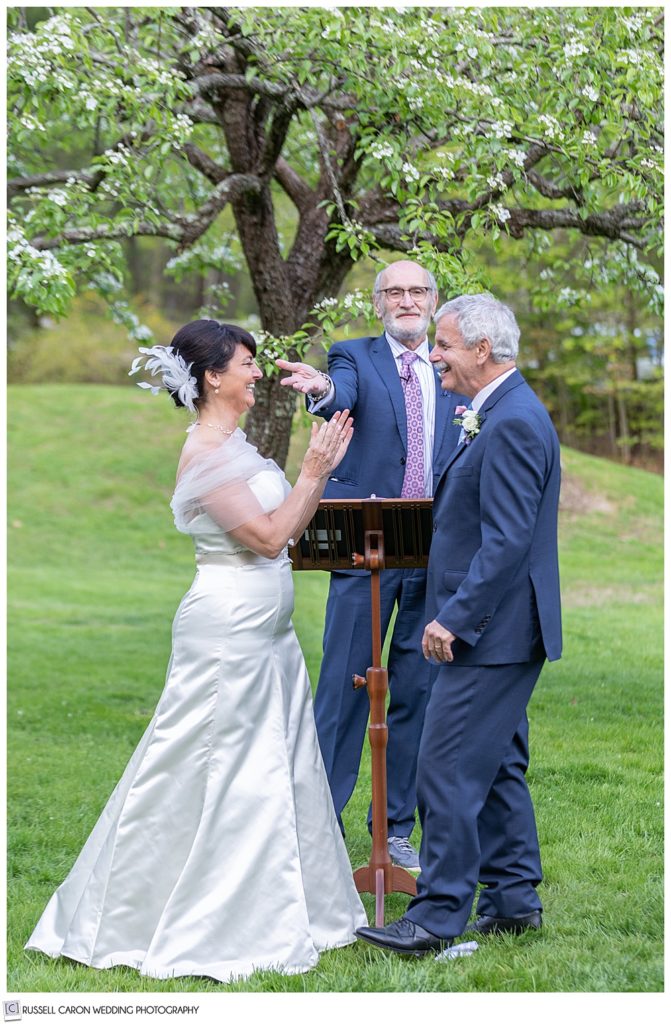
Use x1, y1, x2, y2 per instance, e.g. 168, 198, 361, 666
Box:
7, 7, 663, 463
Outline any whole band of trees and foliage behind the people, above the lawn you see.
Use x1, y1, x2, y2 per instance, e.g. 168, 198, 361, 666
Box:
8, 7, 663, 467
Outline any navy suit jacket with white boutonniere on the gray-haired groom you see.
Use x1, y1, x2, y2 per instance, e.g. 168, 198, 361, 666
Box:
426, 371, 561, 665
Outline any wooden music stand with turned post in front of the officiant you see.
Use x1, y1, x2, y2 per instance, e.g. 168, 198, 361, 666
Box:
289, 498, 432, 928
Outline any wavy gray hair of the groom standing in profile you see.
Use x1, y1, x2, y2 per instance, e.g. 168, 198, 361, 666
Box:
433, 292, 519, 362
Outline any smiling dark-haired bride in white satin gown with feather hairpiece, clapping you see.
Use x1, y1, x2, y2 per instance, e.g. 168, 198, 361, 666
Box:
26, 319, 367, 982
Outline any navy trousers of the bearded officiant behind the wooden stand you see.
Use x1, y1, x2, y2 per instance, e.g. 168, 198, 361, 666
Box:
314, 569, 432, 836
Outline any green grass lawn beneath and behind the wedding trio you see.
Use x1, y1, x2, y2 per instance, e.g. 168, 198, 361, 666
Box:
7, 385, 663, 993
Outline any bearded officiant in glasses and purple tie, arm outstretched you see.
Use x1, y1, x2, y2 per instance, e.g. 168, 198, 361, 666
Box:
278, 260, 463, 871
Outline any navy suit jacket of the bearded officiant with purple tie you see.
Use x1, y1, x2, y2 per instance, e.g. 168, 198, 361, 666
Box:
319, 335, 467, 499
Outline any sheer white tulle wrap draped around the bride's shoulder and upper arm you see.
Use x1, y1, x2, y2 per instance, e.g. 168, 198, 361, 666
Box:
170, 430, 290, 534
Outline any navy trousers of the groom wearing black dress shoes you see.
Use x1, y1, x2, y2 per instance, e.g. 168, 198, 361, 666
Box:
407, 659, 543, 938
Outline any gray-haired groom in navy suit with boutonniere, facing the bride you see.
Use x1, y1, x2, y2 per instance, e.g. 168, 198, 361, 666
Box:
357, 295, 561, 955
